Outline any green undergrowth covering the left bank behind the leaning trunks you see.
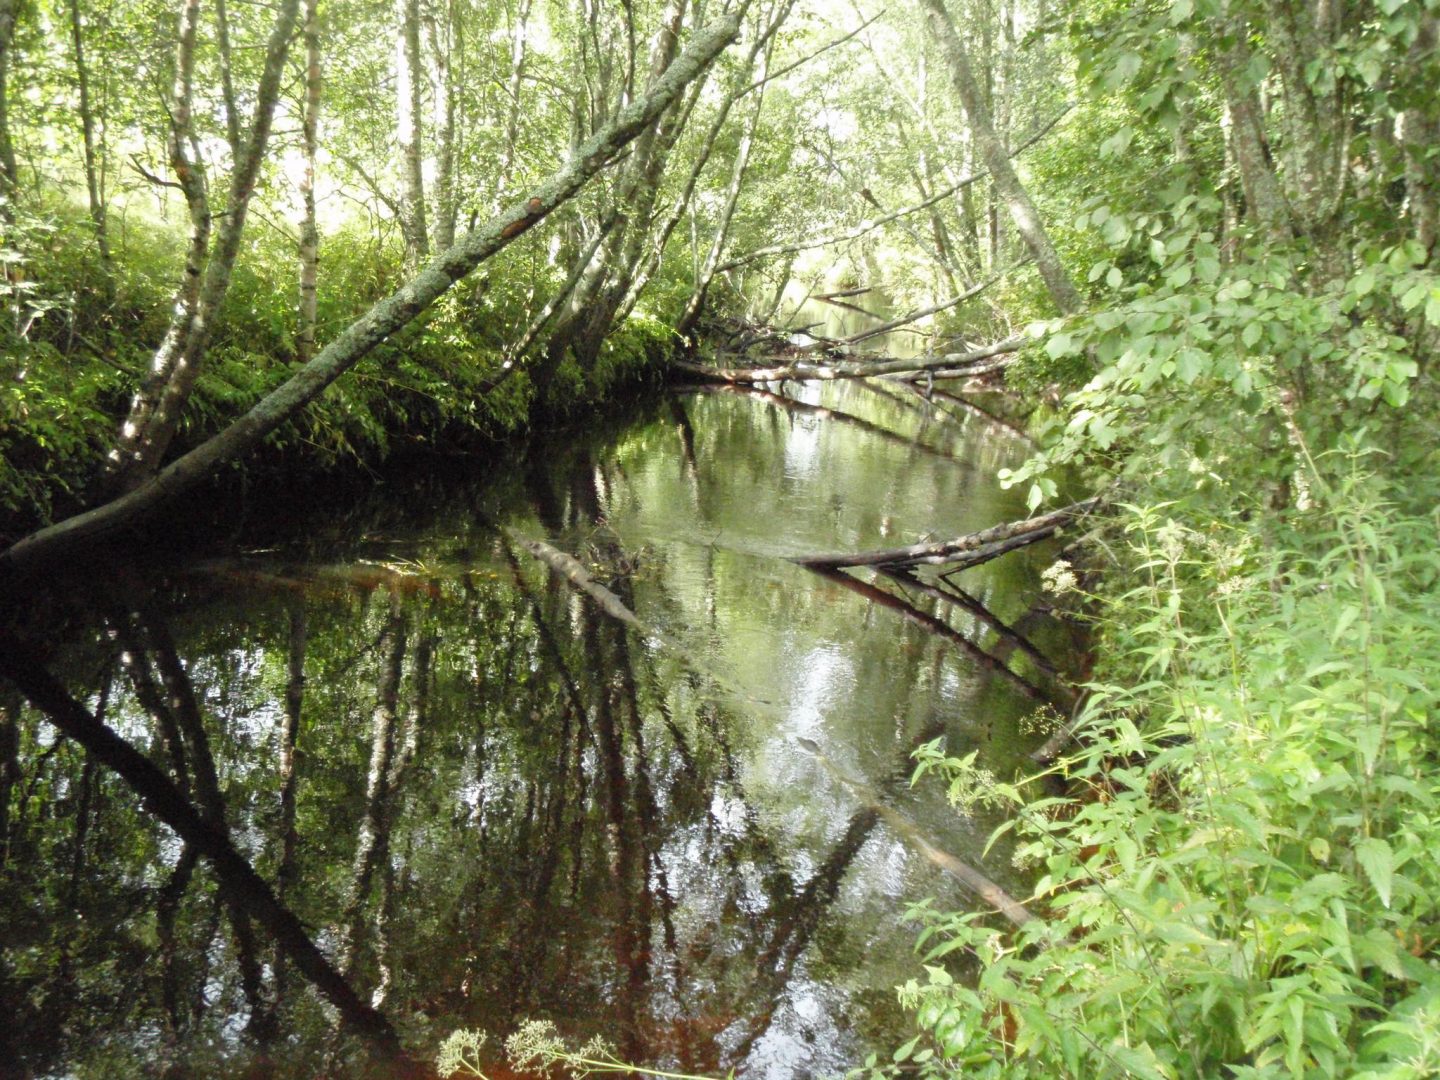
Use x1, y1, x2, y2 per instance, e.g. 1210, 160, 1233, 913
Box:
0, 197, 674, 534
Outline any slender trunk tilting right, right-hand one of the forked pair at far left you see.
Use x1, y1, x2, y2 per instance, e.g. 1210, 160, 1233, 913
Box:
121, 0, 300, 488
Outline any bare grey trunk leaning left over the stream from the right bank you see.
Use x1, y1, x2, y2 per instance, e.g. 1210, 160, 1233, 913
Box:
922, 0, 1081, 315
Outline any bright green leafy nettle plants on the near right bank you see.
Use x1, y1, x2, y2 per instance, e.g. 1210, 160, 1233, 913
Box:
863, 460, 1440, 1079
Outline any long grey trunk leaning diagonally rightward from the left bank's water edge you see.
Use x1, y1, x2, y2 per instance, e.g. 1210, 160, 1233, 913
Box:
8, 4, 744, 570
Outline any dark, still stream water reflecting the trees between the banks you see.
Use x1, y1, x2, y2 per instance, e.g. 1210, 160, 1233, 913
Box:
0, 384, 1070, 1079
